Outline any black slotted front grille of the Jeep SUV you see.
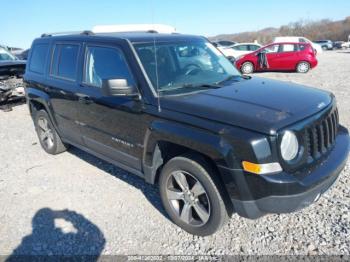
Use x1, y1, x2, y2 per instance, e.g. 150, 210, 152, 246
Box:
305, 109, 339, 162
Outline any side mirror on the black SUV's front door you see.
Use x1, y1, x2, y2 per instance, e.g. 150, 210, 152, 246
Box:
102, 79, 139, 97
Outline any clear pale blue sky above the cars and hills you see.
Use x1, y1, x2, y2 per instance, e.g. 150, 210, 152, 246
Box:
0, 0, 350, 48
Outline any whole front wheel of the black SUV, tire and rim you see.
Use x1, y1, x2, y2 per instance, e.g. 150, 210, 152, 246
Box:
159, 155, 228, 236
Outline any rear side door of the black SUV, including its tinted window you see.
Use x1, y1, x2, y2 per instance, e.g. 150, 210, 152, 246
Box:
47, 42, 82, 144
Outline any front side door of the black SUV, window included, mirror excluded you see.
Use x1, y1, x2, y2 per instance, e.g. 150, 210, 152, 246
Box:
78, 44, 147, 171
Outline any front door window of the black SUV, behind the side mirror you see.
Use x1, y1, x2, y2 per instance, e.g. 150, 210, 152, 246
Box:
84, 46, 134, 87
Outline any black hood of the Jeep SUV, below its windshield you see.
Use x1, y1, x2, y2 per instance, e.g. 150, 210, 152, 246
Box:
162, 77, 333, 134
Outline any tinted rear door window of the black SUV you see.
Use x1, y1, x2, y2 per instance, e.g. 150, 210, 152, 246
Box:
51, 44, 79, 80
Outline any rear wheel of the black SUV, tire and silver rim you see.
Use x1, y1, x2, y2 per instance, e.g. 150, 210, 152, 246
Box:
34, 110, 67, 155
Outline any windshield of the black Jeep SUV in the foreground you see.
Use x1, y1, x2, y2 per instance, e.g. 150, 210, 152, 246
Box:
134, 40, 240, 94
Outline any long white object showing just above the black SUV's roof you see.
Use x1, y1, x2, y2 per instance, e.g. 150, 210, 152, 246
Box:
92, 24, 176, 34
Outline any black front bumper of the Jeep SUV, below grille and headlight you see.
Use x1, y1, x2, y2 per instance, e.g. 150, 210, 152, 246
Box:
220, 128, 349, 219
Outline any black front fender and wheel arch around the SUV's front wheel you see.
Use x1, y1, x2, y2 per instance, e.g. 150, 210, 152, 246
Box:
143, 122, 232, 214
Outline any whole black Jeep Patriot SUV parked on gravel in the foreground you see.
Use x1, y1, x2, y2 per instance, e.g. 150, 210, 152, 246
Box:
24, 32, 349, 236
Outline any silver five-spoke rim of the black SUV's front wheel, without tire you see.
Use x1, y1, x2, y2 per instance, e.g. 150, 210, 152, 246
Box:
166, 171, 211, 226
